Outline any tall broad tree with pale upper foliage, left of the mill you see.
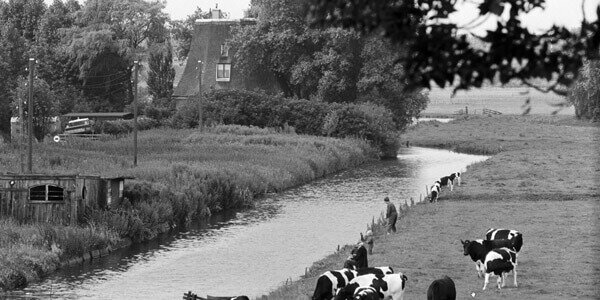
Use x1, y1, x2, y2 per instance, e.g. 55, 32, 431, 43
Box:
69, 0, 166, 111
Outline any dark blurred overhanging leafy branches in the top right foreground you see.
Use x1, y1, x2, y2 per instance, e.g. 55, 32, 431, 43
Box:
308, 0, 600, 95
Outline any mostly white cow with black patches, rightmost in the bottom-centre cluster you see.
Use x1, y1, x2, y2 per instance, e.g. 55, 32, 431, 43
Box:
335, 273, 408, 300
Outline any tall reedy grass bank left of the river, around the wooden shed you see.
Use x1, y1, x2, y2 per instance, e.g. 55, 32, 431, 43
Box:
0, 126, 376, 290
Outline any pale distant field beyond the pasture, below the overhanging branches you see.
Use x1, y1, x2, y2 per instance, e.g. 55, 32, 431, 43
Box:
421, 87, 575, 116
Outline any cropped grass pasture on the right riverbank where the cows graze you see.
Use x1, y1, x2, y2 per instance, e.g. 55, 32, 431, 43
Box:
269, 116, 600, 299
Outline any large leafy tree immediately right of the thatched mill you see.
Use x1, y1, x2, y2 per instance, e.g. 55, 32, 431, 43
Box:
231, 0, 427, 129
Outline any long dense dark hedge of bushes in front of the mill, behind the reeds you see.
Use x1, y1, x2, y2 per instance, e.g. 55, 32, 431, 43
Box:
171, 90, 399, 158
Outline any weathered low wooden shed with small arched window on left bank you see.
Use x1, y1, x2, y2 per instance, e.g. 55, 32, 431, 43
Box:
0, 174, 127, 225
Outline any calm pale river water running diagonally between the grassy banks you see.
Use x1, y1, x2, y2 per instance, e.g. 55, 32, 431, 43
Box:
9, 147, 486, 299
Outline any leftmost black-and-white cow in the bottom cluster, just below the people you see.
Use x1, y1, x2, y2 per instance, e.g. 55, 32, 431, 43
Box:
312, 267, 394, 300
